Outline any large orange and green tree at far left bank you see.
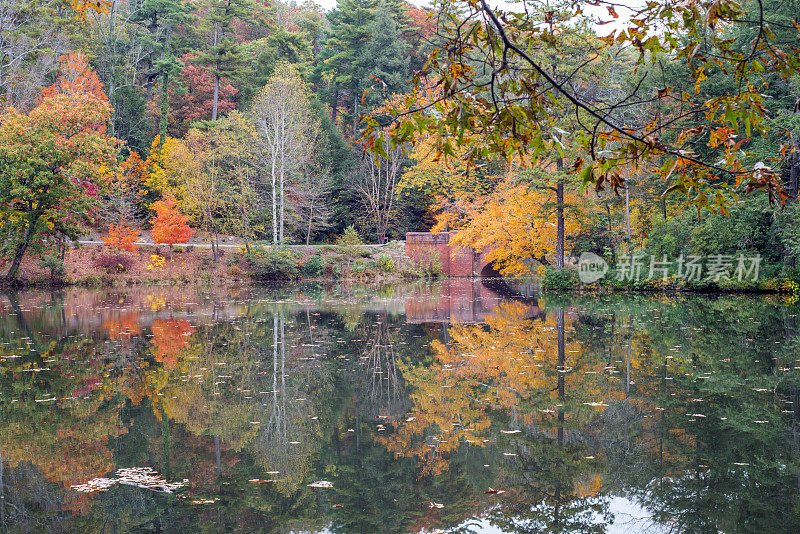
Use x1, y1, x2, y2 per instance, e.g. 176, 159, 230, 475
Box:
0, 54, 120, 280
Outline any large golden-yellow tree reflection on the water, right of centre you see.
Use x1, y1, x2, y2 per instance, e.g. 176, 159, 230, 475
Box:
379, 302, 621, 476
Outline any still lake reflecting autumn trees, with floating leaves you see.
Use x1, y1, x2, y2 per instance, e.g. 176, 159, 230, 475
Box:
0, 280, 800, 534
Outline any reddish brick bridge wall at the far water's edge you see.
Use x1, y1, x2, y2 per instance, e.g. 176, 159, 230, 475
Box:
406, 232, 500, 278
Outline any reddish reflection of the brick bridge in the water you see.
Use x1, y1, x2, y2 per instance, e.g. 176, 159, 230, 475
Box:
406, 278, 543, 324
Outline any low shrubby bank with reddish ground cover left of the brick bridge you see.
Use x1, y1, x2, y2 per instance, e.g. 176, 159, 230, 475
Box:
3, 233, 442, 287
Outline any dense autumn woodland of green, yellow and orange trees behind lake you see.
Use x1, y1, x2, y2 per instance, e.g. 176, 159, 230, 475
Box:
0, 0, 800, 284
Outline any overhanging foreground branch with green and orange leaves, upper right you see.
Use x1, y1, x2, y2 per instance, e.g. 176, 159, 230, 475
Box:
364, 0, 800, 211
